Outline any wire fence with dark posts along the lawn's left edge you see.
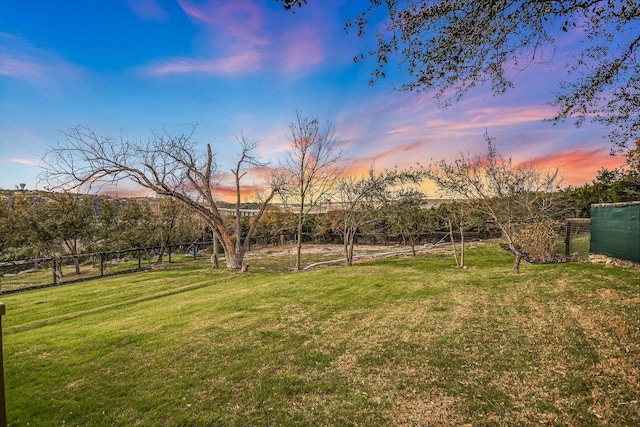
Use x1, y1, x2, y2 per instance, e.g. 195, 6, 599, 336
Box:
0, 242, 213, 295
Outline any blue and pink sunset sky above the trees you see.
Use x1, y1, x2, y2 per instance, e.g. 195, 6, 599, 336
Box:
0, 0, 624, 196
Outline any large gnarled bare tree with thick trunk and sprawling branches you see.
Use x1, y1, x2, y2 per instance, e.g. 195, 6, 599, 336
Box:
40, 127, 282, 270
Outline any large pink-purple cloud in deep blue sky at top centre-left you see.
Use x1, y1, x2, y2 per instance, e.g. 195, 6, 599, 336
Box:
141, 0, 326, 78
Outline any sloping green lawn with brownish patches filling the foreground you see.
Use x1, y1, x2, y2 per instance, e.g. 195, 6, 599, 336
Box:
2, 244, 640, 426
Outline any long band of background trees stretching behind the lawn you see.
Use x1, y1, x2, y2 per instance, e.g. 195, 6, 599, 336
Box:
0, 135, 640, 272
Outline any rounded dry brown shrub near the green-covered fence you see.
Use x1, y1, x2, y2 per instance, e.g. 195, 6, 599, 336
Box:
514, 219, 560, 262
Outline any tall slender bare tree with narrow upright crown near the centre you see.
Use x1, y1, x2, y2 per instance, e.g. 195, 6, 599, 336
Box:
281, 111, 342, 270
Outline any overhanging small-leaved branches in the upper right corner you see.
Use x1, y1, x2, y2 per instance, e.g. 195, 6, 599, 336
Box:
278, 0, 640, 150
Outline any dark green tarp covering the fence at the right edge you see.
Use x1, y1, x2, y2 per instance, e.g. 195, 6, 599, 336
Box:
589, 201, 640, 263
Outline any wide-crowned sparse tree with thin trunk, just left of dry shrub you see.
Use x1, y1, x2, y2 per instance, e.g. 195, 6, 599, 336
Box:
427, 135, 560, 273
